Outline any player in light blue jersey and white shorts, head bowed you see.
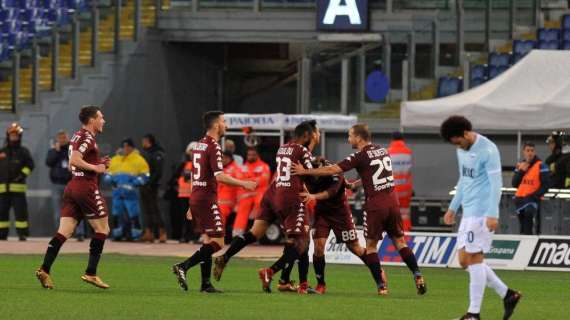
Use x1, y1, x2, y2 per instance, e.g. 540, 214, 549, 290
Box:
440, 116, 522, 320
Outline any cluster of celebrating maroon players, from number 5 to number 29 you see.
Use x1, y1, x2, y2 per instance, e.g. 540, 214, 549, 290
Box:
173, 111, 426, 295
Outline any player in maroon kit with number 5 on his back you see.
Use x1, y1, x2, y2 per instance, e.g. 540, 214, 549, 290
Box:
172, 111, 257, 293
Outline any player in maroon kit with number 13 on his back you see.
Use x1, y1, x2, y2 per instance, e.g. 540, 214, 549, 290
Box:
214, 121, 319, 292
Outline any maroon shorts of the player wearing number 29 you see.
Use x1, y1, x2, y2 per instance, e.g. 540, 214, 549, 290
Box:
362, 206, 404, 240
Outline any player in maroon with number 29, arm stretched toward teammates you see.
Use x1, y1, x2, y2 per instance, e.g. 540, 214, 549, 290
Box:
292, 124, 426, 295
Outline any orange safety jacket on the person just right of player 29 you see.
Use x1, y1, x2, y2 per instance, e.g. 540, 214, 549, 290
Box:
388, 140, 413, 199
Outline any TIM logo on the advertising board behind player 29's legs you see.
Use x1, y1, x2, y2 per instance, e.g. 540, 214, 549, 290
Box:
378, 235, 457, 266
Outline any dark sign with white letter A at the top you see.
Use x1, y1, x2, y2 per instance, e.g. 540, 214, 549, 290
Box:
317, 0, 368, 31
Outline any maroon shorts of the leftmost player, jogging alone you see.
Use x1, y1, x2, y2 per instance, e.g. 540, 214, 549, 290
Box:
61, 180, 109, 221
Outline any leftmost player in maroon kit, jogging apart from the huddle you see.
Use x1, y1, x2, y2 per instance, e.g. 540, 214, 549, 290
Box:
36, 106, 109, 289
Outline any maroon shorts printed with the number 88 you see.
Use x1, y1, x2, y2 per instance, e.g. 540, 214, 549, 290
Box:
313, 206, 358, 243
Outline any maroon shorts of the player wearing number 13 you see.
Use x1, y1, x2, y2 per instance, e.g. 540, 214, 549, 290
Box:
256, 197, 309, 237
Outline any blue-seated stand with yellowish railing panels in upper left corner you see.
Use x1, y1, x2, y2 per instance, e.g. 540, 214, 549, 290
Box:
0, 0, 155, 112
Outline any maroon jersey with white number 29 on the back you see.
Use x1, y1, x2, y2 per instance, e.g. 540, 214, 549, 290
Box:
338, 144, 397, 211
